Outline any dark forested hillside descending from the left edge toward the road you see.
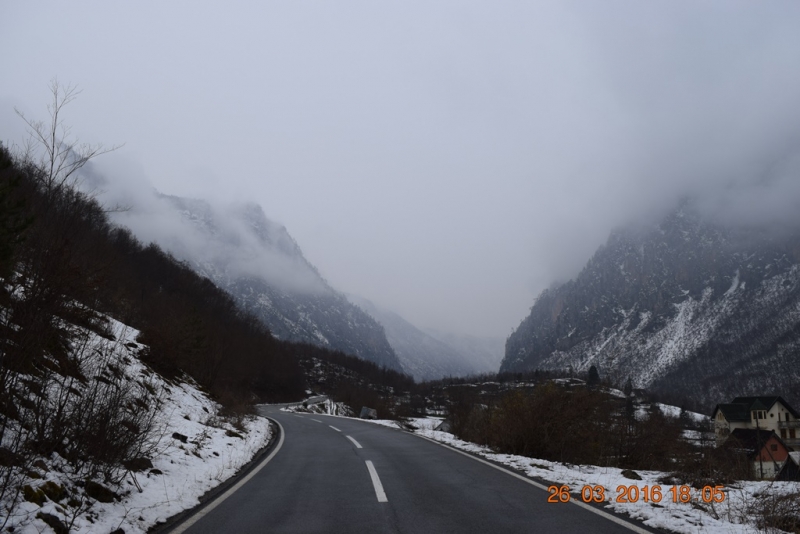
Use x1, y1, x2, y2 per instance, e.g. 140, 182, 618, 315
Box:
0, 131, 410, 412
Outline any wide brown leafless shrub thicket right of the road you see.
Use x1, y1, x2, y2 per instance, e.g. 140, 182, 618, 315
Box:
450, 382, 684, 469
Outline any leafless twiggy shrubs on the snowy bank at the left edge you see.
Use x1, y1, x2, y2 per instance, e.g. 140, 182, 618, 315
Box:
0, 318, 163, 528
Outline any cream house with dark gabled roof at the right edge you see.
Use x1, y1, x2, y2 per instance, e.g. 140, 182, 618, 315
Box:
711, 396, 800, 449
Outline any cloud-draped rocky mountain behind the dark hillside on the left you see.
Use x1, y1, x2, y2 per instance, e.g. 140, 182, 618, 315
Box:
158, 196, 402, 370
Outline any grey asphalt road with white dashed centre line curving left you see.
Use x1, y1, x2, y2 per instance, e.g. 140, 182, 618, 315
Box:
172, 406, 650, 534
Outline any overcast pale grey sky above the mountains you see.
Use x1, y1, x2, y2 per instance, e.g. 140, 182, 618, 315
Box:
0, 0, 800, 336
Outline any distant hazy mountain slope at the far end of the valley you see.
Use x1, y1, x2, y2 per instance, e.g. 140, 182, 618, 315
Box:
348, 295, 480, 381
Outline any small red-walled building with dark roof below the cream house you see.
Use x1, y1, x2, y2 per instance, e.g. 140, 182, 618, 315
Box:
722, 428, 789, 479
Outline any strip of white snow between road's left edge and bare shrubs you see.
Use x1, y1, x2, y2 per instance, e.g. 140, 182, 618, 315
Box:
6, 320, 270, 534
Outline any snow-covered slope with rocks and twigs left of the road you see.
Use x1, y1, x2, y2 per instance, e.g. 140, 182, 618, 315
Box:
0, 320, 270, 533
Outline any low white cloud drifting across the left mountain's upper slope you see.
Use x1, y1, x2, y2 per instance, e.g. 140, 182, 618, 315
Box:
82, 156, 330, 293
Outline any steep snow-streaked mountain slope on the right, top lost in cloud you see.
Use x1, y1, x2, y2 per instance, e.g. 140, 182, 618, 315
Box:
501, 203, 800, 406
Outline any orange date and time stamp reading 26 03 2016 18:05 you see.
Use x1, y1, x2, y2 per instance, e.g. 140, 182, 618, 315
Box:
547, 484, 725, 503
